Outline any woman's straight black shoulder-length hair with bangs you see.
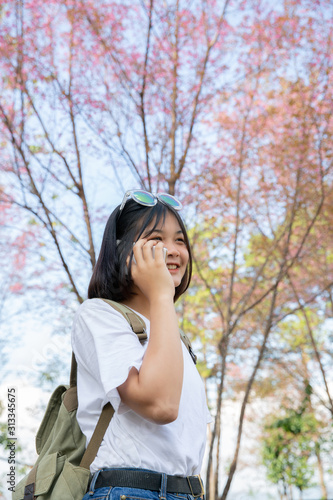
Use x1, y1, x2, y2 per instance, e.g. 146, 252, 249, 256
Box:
88, 200, 192, 302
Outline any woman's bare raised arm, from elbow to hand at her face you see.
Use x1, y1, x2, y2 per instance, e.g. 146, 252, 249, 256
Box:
118, 239, 183, 424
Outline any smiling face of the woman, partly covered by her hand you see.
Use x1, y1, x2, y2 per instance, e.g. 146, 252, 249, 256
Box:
143, 212, 189, 288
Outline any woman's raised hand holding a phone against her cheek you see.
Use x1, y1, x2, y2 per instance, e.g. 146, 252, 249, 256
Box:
131, 238, 175, 301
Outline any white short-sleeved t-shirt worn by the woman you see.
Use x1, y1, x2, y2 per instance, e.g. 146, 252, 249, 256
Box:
72, 299, 211, 476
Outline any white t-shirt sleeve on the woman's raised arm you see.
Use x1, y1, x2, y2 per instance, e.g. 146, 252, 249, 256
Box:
72, 299, 144, 413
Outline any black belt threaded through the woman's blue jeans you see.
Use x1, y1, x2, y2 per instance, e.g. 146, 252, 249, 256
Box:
95, 469, 204, 498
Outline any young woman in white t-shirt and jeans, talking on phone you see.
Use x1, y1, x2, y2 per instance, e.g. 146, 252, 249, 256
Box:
72, 190, 210, 500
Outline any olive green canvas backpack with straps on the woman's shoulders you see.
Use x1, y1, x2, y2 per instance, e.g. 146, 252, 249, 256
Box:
12, 299, 195, 500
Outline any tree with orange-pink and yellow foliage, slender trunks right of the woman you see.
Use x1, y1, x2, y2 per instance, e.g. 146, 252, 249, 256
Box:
180, 2, 332, 499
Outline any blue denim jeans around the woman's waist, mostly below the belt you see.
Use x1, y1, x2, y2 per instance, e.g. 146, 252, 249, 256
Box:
82, 469, 204, 500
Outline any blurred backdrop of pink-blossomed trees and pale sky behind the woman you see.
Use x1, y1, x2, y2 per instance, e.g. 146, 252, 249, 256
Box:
0, 0, 333, 500
